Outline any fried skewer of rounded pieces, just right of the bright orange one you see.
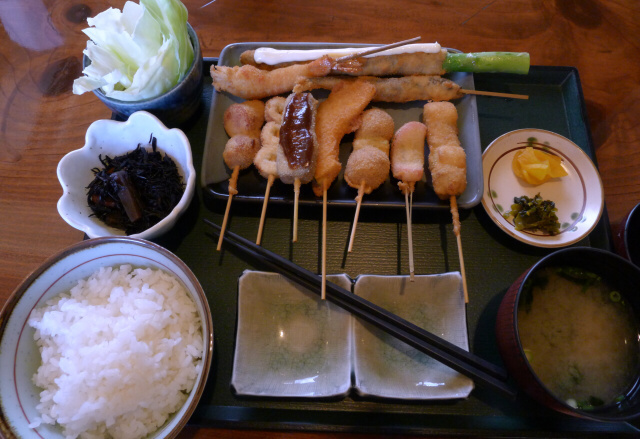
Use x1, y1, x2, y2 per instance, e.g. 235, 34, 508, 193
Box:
344, 108, 394, 252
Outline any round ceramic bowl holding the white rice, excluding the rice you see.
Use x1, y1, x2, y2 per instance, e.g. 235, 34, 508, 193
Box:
0, 237, 213, 439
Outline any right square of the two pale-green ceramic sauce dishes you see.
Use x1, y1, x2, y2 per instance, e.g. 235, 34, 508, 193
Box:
353, 272, 474, 400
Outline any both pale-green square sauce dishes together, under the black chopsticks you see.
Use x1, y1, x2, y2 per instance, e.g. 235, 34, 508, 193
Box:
231, 271, 473, 400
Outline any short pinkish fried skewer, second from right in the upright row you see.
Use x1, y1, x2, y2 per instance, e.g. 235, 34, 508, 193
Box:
391, 122, 427, 281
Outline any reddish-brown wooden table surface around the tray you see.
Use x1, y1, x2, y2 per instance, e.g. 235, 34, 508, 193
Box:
0, 0, 640, 439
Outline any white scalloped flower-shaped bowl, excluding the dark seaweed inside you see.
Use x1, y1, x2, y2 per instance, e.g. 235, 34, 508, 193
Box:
58, 111, 196, 239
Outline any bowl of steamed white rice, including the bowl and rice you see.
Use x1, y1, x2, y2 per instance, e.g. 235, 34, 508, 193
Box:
0, 237, 213, 439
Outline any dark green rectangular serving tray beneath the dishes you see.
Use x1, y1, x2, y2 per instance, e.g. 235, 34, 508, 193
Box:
149, 59, 638, 437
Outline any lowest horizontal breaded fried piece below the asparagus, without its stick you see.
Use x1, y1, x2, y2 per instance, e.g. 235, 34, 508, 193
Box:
293, 75, 464, 103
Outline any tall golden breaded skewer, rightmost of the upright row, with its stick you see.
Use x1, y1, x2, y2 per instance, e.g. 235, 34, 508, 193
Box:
423, 102, 469, 302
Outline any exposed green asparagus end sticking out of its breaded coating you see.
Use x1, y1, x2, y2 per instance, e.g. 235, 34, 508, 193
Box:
442, 52, 529, 75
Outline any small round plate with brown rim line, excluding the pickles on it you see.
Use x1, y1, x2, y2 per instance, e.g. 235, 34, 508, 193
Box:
482, 128, 604, 248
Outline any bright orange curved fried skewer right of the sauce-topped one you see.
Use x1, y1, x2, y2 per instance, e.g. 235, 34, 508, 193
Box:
313, 81, 376, 299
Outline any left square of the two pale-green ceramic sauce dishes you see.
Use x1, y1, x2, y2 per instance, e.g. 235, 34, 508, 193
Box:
231, 271, 351, 398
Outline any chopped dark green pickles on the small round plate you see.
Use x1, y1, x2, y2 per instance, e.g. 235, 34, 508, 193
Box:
503, 193, 560, 235
